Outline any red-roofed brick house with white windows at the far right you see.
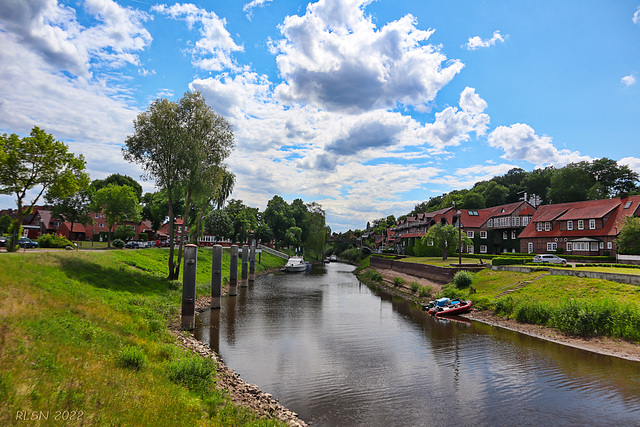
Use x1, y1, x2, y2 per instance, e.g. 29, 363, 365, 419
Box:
520, 196, 640, 256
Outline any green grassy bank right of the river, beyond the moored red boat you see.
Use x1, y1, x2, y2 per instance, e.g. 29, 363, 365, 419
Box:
363, 258, 640, 343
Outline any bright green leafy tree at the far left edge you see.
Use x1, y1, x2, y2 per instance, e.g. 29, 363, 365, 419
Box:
0, 126, 87, 251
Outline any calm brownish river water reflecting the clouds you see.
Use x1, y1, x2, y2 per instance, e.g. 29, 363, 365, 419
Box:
196, 263, 640, 426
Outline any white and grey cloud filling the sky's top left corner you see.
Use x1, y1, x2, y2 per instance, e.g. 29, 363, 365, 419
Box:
0, 0, 151, 78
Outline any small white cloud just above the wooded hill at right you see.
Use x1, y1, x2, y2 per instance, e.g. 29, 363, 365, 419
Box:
488, 123, 591, 167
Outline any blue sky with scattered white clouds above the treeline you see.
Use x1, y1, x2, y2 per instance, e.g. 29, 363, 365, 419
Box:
0, 0, 640, 231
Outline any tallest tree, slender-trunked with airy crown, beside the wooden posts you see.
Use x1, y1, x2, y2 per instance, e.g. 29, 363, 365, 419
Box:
123, 92, 233, 279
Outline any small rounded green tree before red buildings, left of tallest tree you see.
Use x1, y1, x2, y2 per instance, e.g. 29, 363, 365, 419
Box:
91, 184, 142, 247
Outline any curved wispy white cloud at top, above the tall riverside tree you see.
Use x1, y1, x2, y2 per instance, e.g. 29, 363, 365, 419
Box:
151, 3, 246, 71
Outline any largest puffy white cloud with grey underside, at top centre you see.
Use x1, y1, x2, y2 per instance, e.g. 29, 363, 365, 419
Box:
271, 0, 463, 112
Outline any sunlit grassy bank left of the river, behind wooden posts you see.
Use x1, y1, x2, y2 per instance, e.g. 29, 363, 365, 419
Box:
0, 249, 283, 426
